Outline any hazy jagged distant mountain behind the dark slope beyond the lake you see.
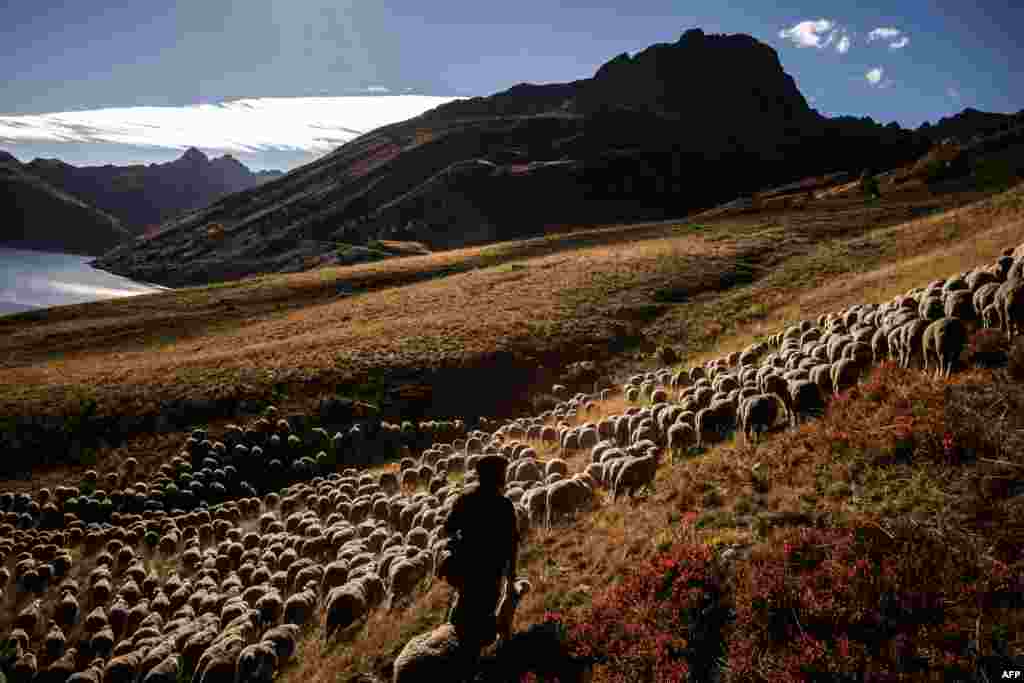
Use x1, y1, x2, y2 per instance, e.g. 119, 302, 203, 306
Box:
26, 147, 283, 234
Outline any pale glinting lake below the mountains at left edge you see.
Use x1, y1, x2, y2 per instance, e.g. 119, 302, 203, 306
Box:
0, 247, 167, 315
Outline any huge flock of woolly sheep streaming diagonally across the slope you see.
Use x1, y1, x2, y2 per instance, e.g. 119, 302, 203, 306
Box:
0, 245, 1024, 683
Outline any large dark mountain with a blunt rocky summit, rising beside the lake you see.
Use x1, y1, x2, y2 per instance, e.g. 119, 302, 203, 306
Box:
86, 29, 999, 286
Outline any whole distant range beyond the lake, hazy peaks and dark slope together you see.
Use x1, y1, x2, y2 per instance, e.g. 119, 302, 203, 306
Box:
0, 148, 283, 255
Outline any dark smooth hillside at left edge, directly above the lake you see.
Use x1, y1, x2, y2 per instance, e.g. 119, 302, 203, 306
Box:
0, 152, 131, 256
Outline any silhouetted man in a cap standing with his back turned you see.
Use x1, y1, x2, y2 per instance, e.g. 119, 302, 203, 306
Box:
444, 455, 519, 652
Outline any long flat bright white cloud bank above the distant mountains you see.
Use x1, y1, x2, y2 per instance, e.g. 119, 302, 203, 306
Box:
0, 95, 459, 153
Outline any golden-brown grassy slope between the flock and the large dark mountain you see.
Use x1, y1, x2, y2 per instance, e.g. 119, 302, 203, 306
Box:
0, 189, 995, 483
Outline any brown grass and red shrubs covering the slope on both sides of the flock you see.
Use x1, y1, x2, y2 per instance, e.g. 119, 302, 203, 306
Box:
0, 179, 1024, 683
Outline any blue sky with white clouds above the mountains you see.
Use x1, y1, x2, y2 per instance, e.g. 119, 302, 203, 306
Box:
0, 0, 1024, 168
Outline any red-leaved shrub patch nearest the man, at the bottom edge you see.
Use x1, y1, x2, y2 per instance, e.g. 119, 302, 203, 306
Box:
546, 543, 728, 683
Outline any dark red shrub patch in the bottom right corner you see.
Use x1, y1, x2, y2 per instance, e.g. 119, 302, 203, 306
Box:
725, 524, 1024, 681
